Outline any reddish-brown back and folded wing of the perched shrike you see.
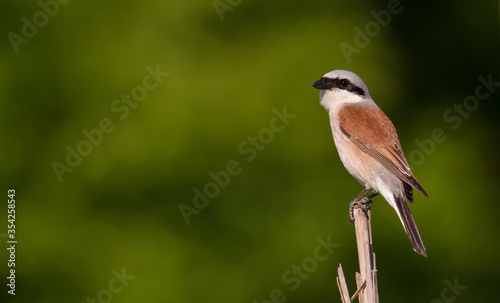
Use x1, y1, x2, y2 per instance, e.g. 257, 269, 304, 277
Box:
339, 104, 427, 203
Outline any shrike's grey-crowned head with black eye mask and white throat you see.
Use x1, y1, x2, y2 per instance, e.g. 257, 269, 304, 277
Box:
312, 69, 373, 111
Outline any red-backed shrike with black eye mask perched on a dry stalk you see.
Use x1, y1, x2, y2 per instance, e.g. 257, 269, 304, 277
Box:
312, 69, 428, 257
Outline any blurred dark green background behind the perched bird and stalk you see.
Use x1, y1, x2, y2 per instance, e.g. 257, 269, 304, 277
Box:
0, 0, 500, 302
